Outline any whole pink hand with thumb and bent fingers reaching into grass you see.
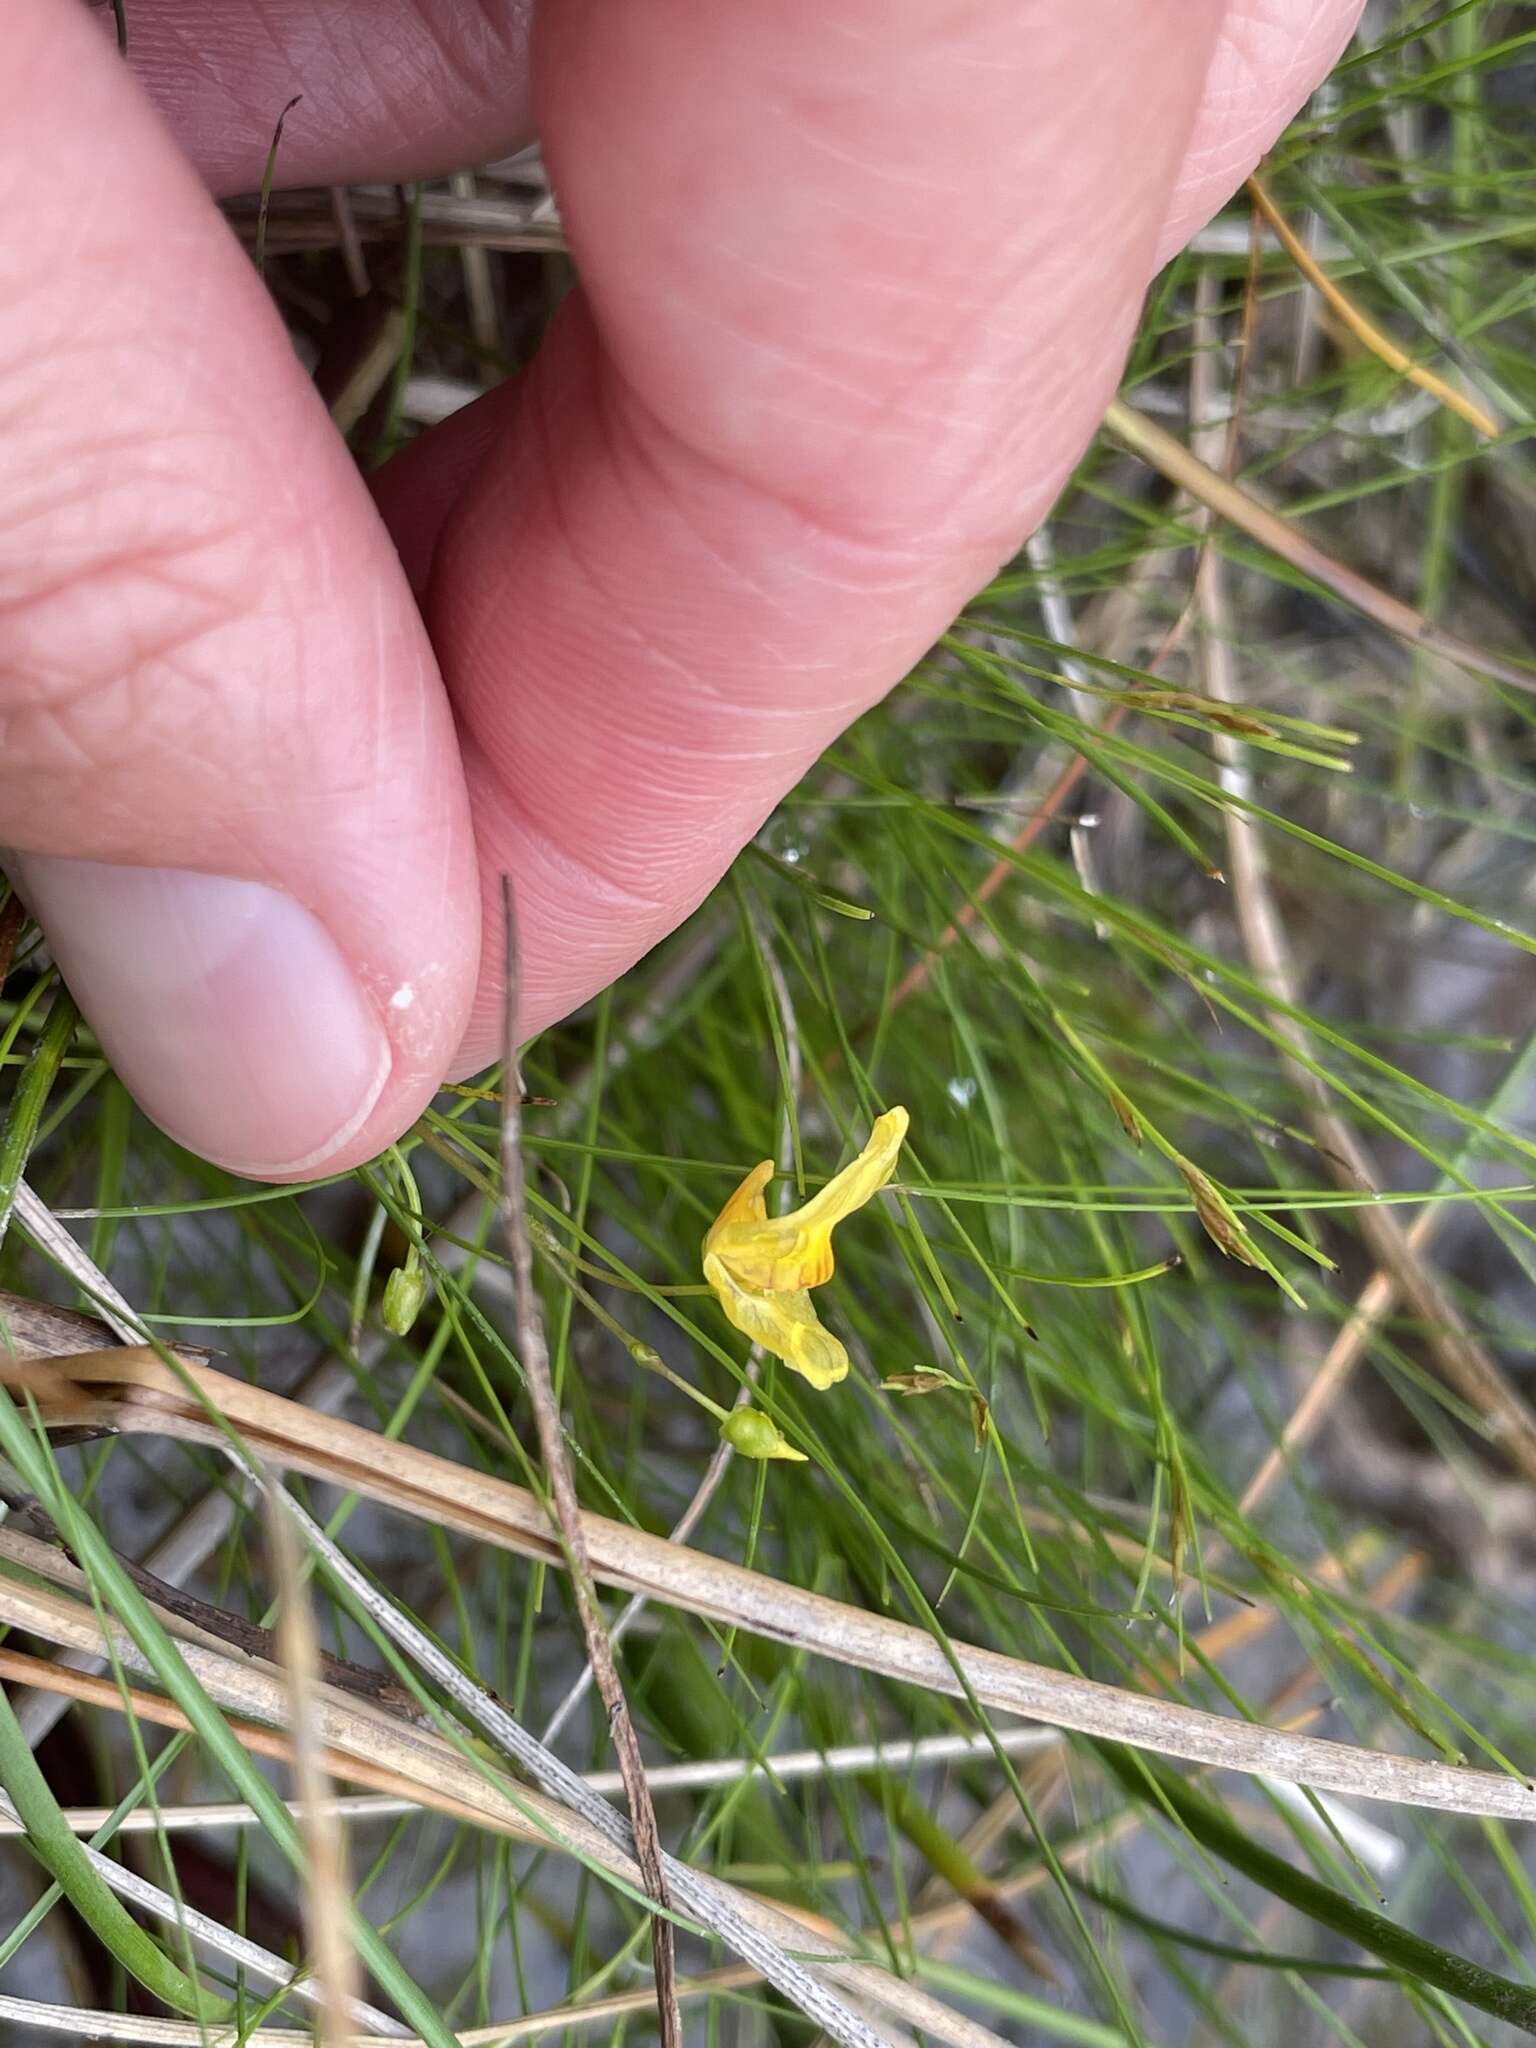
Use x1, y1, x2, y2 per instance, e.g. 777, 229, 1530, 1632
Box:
0, 0, 1360, 1180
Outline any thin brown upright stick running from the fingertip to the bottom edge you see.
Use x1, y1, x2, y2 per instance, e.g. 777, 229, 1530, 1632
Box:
502, 874, 682, 2048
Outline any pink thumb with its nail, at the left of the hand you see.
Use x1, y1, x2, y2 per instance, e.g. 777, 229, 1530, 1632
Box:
0, 0, 477, 1178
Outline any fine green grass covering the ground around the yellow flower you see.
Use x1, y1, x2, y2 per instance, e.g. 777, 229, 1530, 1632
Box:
0, 4, 1536, 2044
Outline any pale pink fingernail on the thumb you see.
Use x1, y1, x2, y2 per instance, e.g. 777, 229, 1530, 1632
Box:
8, 856, 389, 1178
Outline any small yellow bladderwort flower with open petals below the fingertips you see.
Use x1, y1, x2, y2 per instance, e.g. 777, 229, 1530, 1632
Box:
705, 1110, 907, 1386
